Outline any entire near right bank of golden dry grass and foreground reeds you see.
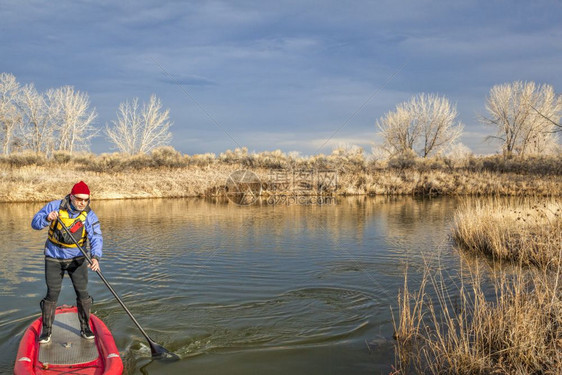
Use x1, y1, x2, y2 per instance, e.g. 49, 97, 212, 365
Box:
395, 199, 562, 375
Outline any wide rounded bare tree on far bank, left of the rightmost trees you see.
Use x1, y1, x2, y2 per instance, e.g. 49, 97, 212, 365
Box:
377, 94, 462, 158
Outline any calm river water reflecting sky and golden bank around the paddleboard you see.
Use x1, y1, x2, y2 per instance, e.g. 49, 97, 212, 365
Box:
0, 197, 458, 374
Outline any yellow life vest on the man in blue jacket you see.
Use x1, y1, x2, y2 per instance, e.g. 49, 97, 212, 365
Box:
49, 196, 90, 248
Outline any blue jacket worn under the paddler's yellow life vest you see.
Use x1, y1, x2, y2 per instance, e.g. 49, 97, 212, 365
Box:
31, 200, 103, 260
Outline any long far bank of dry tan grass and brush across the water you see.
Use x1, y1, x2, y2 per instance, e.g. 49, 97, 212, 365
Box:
0, 147, 562, 202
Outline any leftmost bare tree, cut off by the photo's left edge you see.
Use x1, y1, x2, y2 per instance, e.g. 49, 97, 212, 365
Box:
0, 73, 21, 155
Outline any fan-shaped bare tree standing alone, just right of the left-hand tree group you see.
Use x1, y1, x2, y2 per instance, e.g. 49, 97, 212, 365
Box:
105, 95, 172, 155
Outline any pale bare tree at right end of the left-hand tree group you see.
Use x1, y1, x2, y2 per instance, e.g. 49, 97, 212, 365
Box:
46, 86, 97, 153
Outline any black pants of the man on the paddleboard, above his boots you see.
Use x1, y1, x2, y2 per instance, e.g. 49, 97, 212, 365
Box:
45, 257, 90, 302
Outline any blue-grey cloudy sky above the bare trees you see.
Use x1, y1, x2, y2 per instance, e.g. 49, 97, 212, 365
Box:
0, 0, 562, 155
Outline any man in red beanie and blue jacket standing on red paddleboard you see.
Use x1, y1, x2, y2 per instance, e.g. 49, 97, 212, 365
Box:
31, 181, 103, 344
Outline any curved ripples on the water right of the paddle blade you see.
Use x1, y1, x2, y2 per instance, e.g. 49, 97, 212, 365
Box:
117, 287, 375, 357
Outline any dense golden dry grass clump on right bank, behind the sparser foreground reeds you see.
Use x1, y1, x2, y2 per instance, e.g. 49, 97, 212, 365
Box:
452, 200, 562, 269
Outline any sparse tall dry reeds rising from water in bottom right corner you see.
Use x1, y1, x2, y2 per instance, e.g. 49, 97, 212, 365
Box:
395, 258, 562, 375
